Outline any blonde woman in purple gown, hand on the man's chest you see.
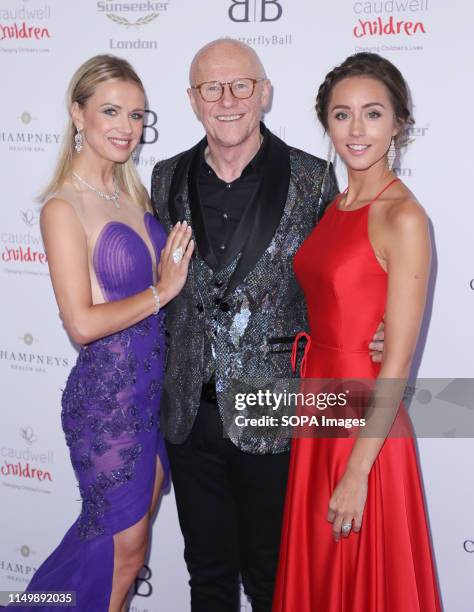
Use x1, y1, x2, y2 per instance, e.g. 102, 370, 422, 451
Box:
21, 55, 194, 612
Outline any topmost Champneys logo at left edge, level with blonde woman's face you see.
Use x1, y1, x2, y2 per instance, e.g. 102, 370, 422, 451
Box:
0, 110, 62, 153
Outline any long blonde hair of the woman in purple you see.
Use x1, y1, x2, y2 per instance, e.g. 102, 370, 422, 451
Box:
39, 55, 150, 209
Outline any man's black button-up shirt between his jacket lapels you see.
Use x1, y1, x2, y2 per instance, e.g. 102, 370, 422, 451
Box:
198, 128, 268, 263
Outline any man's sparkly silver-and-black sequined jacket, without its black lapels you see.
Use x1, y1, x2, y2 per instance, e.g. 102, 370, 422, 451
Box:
152, 130, 337, 454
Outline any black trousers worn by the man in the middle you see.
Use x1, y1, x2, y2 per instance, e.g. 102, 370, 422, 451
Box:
167, 384, 289, 612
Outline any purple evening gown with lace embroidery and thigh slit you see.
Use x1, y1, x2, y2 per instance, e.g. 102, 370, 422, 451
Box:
18, 213, 169, 612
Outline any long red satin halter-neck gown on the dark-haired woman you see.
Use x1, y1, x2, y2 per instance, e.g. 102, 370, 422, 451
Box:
273, 181, 441, 612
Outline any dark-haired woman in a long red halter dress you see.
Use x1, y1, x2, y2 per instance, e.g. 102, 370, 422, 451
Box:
274, 53, 441, 612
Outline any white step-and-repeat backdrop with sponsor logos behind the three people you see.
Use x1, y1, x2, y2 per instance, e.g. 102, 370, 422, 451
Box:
0, 0, 474, 612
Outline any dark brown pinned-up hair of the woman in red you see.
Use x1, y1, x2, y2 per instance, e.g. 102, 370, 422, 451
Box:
315, 53, 415, 147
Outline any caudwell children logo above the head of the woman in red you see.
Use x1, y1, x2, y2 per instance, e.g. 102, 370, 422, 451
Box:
352, 0, 428, 44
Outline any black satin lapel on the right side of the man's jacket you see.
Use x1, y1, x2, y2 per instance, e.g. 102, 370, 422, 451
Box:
225, 133, 290, 295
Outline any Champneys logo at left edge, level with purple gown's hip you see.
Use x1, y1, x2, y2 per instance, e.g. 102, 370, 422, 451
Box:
0, 332, 71, 374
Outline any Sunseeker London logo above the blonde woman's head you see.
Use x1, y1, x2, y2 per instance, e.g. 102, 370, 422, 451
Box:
97, 0, 170, 50
